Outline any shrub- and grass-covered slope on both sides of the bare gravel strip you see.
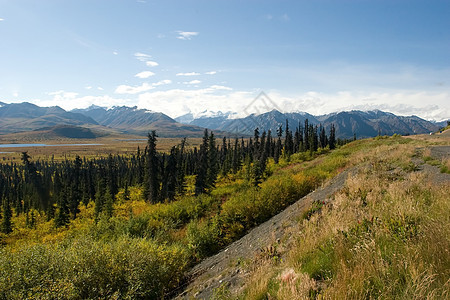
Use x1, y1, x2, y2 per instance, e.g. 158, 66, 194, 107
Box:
0, 136, 450, 299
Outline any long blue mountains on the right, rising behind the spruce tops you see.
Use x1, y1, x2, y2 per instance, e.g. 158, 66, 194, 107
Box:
179, 110, 439, 138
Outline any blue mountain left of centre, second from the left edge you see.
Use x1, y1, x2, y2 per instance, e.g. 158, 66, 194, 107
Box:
72, 106, 204, 137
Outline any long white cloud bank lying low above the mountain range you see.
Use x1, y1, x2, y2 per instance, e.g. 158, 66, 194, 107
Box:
32, 84, 450, 121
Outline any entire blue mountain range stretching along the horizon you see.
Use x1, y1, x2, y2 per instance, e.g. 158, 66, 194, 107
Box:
0, 102, 446, 138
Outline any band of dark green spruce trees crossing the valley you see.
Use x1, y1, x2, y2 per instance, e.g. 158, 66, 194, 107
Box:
0, 120, 348, 234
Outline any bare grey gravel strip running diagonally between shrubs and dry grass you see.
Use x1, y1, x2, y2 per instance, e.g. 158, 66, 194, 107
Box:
176, 146, 450, 299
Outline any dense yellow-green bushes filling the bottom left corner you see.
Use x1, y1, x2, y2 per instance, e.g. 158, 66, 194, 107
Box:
0, 237, 188, 299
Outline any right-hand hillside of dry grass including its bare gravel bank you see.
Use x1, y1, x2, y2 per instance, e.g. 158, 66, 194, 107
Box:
177, 138, 450, 299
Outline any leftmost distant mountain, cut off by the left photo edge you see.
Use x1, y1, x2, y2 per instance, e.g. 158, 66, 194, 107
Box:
0, 102, 98, 134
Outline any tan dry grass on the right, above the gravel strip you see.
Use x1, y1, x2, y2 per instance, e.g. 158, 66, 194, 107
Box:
244, 138, 450, 299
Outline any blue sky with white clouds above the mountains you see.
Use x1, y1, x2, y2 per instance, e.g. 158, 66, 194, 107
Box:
0, 0, 450, 121
